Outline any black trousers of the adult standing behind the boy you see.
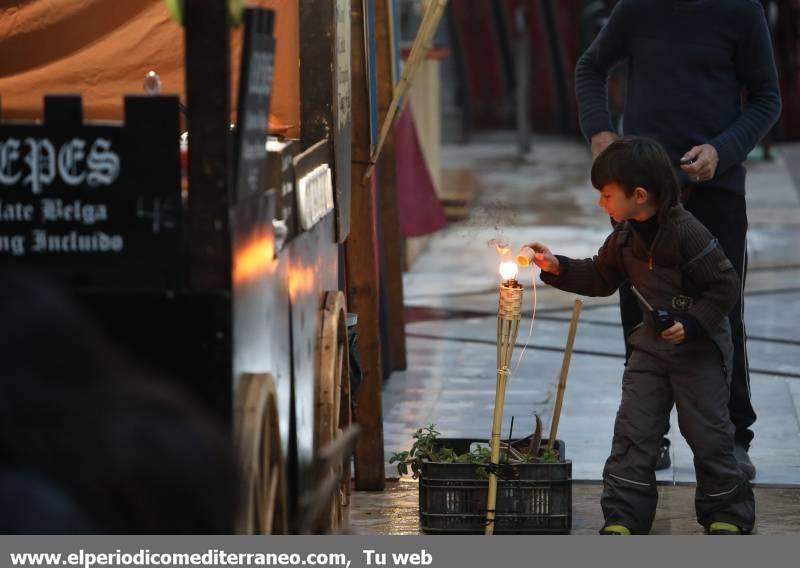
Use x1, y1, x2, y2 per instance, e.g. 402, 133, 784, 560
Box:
619, 185, 756, 449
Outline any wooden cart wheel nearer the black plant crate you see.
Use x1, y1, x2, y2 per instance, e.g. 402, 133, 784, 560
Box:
314, 291, 351, 532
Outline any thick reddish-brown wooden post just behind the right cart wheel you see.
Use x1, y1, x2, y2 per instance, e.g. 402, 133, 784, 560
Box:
345, 0, 385, 491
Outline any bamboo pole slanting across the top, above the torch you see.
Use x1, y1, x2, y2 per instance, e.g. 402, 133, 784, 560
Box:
362, 0, 447, 183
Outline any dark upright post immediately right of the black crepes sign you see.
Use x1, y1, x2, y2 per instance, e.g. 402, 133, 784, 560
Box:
184, 0, 233, 290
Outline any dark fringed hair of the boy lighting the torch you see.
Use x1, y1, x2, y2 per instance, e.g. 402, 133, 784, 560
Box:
592, 137, 680, 221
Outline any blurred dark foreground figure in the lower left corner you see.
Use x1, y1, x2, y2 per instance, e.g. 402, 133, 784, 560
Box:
0, 271, 239, 534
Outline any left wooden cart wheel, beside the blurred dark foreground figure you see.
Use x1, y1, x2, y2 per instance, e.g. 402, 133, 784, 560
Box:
235, 374, 287, 534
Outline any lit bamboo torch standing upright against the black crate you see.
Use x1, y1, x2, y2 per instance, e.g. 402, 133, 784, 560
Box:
486, 262, 522, 535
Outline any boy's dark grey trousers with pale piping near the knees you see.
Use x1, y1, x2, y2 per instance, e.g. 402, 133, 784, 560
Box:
601, 326, 755, 534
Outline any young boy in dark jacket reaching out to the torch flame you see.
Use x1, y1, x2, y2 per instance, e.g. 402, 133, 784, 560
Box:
528, 138, 755, 535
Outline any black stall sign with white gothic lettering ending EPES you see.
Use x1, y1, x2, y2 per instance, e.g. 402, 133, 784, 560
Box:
0, 96, 181, 286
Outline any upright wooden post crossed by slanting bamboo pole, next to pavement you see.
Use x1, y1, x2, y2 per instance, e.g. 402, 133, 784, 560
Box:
375, 0, 406, 371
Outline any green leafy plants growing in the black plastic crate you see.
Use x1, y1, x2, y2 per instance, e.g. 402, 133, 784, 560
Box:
389, 416, 559, 479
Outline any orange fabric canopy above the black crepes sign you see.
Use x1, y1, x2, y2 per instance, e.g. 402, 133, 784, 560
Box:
0, 0, 300, 137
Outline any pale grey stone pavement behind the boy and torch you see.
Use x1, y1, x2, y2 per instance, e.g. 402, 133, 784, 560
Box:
383, 133, 800, 487
